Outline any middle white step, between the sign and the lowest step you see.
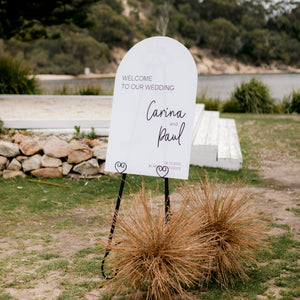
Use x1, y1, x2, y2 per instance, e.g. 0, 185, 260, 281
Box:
190, 111, 220, 167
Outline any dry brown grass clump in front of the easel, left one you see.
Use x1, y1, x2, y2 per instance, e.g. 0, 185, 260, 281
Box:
105, 188, 214, 299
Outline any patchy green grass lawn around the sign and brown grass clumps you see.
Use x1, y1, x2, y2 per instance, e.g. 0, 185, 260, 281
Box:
0, 114, 300, 300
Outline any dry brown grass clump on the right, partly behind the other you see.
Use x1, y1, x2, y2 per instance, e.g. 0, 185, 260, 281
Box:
179, 176, 266, 286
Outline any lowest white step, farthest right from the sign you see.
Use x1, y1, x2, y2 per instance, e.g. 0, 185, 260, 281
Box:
217, 118, 243, 171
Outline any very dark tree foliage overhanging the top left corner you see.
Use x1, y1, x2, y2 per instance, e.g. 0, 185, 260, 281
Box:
0, 0, 97, 39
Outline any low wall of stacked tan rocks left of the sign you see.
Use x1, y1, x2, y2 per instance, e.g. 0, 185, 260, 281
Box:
0, 134, 107, 178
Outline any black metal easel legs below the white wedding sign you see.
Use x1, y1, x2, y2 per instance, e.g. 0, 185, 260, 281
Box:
101, 173, 170, 279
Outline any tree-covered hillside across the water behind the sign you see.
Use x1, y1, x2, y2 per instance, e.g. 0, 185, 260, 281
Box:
0, 0, 300, 75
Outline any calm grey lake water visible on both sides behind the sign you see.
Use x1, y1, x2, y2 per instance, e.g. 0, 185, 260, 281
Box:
41, 74, 300, 101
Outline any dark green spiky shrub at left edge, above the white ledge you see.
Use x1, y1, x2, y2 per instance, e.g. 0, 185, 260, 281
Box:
0, 56, 39, 94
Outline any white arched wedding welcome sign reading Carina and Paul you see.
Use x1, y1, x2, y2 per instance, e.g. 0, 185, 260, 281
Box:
105, 37, 197, 179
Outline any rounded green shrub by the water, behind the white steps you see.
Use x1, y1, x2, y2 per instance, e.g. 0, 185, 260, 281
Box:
223, 78, 275, 113
